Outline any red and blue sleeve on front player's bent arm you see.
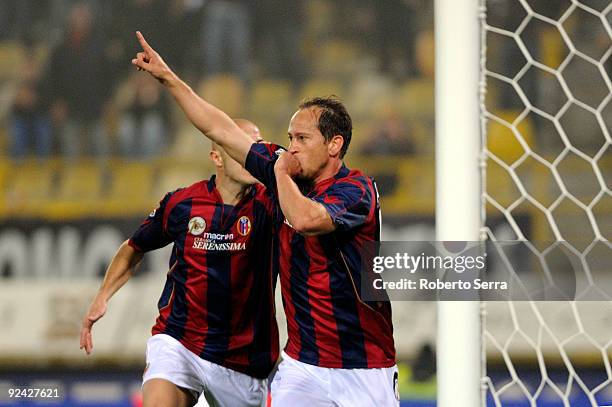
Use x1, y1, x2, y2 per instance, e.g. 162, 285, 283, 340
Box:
312, 177, 376, 231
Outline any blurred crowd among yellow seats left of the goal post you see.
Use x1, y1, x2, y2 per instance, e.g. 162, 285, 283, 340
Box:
0, 0, 433, 160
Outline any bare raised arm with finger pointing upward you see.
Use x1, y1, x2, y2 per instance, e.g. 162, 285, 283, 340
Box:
132, 31, 253, 165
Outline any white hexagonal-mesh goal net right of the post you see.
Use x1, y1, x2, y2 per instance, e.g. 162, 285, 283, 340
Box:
481, 0, 612, 406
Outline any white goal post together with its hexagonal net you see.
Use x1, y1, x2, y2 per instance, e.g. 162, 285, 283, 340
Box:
434, 0, 612, 407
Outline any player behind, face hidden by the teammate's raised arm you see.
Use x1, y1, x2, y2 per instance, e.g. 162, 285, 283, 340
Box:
80, 120, 279, 407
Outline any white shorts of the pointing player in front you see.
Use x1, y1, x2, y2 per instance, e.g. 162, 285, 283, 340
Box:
271, 352, 399, 407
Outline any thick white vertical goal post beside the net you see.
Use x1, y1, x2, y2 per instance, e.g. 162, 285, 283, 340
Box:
434, 0, 482, 407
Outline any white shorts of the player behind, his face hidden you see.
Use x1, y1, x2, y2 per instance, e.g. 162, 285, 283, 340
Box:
142, 334, 268, 407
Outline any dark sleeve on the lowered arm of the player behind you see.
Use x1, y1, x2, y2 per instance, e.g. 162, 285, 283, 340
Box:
128, 193, 174, 252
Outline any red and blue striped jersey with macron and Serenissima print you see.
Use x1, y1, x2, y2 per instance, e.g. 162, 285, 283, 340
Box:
129, 176, 279, 378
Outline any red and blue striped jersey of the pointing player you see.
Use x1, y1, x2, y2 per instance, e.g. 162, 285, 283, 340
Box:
245, 143, 395, 369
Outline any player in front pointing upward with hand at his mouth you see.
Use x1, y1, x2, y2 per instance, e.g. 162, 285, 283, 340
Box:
132, 32, 399, 407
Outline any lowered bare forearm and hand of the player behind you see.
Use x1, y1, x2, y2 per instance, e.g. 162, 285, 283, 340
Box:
80, 241, 144, 355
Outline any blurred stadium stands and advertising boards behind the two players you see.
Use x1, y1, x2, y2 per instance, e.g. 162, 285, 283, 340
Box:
0, 0, 612, 406
